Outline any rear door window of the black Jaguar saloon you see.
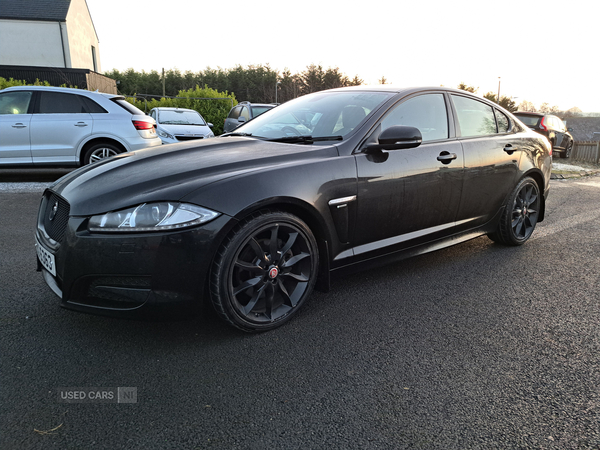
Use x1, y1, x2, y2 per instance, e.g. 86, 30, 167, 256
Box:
452, 95, 496, 137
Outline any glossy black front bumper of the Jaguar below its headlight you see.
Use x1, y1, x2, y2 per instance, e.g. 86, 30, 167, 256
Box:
36, 201, 230, 318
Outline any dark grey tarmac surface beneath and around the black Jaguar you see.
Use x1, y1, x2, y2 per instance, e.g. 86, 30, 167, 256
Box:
0, 161, 600, 450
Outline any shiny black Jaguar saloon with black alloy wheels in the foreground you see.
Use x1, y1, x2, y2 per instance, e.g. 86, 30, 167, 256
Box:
36, 87, 551, 331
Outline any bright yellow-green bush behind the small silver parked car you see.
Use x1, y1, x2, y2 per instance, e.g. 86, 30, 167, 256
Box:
127, 86, 238, 135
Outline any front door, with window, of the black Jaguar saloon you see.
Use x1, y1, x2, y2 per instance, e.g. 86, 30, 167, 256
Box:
353, 92, 463, 256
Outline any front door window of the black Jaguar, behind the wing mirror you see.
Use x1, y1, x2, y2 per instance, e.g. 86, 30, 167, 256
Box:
381, 94, 448, 142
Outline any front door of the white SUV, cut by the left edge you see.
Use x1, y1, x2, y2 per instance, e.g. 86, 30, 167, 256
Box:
0, 91, 33, 164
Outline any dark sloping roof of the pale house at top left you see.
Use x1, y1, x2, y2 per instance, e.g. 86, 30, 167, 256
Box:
0, 0, 71, 22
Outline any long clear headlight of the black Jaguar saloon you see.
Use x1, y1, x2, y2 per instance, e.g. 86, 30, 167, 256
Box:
88, 202, 219, 233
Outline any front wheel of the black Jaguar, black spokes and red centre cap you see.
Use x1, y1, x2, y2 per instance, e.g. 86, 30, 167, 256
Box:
210, 211, 319, 331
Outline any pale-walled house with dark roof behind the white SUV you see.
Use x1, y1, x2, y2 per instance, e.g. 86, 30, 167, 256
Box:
0, 0, 116, 93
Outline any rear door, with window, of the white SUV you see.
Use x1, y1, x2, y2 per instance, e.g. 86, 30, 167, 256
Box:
31, 91, 93, 164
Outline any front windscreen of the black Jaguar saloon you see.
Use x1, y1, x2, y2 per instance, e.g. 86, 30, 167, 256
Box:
234, 91, 394, 140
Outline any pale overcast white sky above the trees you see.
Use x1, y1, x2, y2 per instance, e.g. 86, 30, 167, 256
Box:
87, 0, 600, 112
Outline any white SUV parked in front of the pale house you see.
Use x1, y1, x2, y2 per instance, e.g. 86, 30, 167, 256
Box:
0, 86, 161, 166
